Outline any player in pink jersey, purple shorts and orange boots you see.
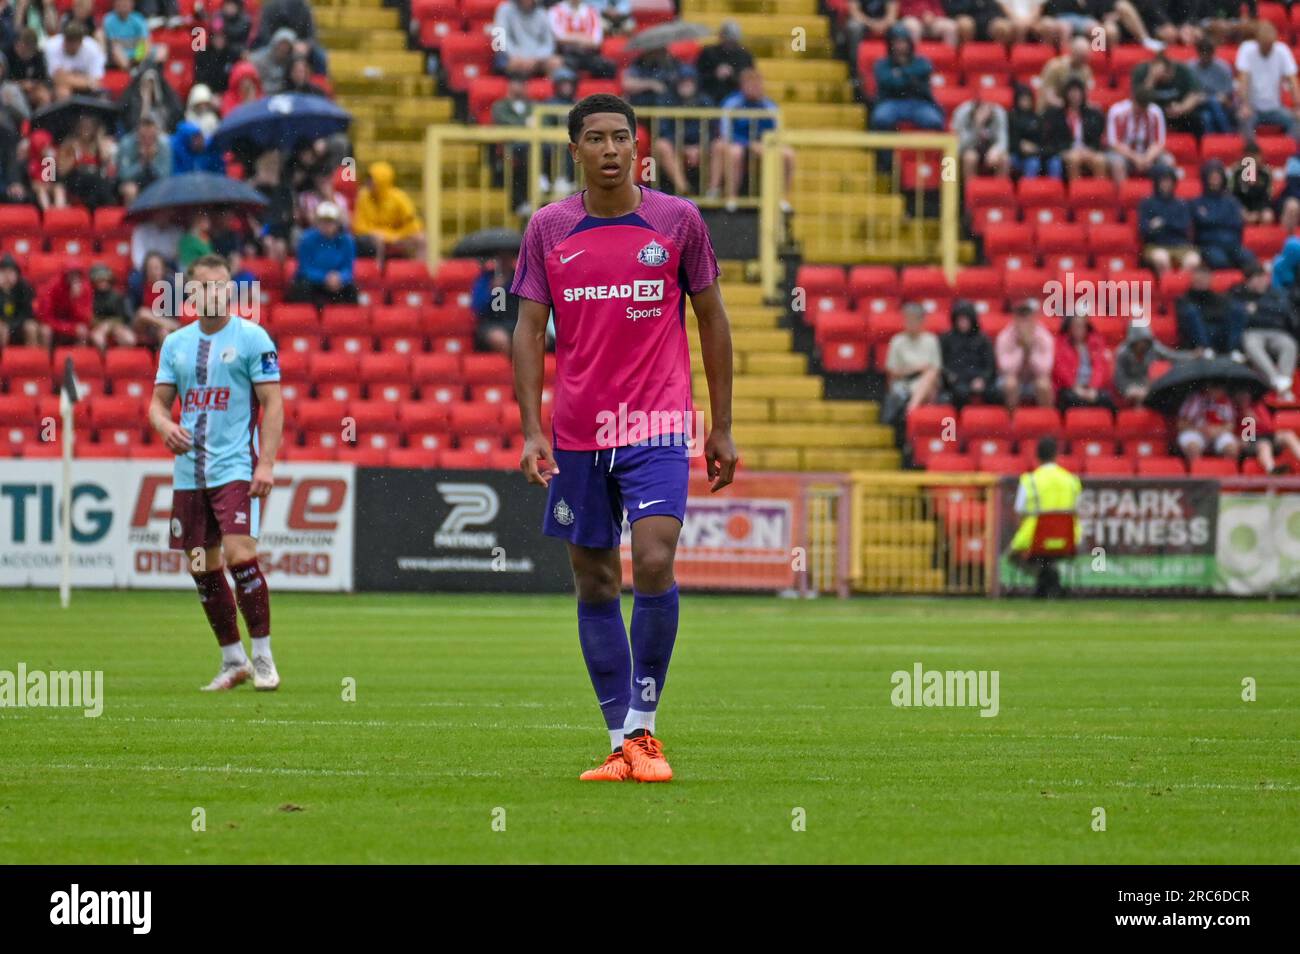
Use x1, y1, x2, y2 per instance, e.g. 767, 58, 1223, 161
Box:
511, 95, 737, 781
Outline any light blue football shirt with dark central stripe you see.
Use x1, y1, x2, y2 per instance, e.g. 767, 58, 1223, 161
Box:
153, 316, 280, 490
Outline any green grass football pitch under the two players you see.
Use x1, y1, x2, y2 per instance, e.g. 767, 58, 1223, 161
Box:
0, 590, 1300, 864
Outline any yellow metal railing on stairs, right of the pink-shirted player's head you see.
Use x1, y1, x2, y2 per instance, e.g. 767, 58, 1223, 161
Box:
759, 129, 959, 299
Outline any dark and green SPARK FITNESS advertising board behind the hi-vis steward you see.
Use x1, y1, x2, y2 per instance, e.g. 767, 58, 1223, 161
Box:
1000, 477, 1219, 593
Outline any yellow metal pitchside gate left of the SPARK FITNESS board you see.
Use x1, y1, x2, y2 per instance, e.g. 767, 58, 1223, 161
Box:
849, 471, 997, 594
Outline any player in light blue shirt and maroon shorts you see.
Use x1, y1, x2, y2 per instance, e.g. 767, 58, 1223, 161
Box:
150, 255, 285, 690
